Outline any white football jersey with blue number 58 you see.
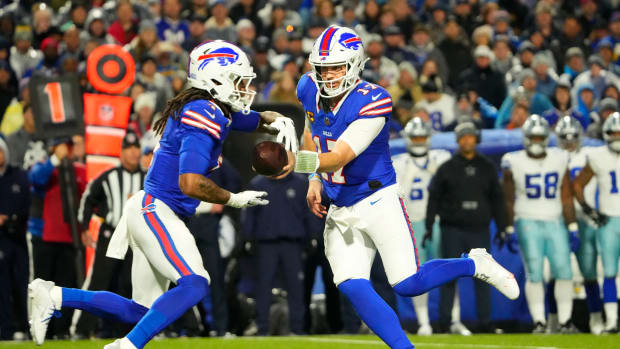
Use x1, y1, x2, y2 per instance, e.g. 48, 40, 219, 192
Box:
502, 148, 568, 221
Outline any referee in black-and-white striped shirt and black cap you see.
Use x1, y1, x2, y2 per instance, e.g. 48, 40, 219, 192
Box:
73, 131, 146, 337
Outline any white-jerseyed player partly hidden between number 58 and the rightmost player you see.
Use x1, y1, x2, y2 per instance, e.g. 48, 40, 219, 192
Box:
549, 115, 603, 334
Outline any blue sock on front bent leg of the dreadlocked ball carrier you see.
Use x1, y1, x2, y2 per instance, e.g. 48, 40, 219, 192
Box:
127, 275, 209, 349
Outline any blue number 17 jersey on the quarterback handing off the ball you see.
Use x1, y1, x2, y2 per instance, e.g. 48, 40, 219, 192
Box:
297, 73, 396, 206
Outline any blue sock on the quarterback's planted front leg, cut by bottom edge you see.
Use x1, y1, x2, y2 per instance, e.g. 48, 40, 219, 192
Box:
338, 279, 414, 349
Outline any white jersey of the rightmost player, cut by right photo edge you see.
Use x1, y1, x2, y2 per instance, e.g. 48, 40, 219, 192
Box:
587, 146, 620, 217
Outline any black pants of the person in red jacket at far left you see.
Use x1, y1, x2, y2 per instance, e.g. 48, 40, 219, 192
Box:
33, 241, 77, 338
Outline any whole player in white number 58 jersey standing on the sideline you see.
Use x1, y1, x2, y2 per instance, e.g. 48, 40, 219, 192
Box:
502, 114, 579, 333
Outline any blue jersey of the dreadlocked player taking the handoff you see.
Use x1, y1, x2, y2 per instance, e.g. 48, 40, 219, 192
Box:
144, 100, 258, 217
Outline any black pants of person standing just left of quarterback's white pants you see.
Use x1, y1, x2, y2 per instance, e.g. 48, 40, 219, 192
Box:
304, 240, 342, 333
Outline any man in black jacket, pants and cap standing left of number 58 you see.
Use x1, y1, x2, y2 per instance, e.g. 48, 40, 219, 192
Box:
423, 121, 506, 332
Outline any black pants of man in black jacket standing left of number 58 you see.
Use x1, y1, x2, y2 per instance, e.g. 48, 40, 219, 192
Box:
439, 225, 491, 331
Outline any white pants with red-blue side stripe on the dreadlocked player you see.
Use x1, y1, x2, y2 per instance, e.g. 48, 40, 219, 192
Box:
123, 190, 210, 308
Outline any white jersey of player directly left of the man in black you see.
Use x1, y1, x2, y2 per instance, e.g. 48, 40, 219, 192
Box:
392, 149, 451, 222
